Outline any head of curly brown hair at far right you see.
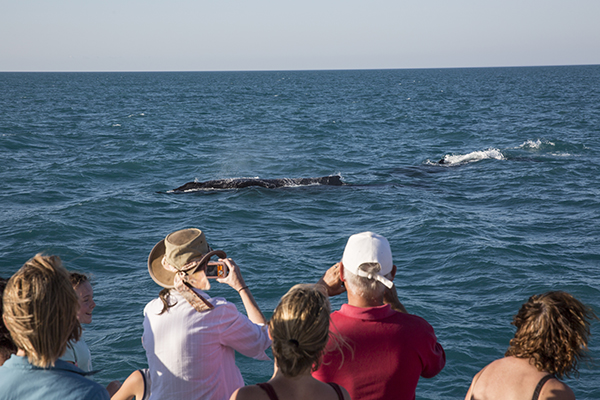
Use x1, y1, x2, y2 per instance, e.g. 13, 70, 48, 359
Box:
505, 291, 596, 378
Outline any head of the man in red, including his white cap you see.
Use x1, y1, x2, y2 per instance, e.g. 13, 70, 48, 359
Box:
341, 232, 396, 298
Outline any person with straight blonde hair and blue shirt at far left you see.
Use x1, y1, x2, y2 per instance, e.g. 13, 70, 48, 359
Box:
0, 254, 109, 400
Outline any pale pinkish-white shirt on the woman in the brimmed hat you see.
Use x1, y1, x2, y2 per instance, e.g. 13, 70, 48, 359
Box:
142, 290, 271, 400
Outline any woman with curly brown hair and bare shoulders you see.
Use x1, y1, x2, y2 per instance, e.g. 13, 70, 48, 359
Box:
465, 291, 596, 400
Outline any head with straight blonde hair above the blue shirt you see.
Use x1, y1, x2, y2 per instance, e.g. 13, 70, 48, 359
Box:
3, 254, 81, 368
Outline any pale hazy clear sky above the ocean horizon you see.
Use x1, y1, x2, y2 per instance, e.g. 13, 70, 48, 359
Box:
0, 0, 600, 71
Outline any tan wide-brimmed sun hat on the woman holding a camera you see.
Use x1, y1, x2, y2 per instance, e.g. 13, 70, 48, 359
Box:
148, 228, 227, 289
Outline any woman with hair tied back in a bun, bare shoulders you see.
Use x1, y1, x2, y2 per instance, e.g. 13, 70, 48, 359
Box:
230, 285, 350, 400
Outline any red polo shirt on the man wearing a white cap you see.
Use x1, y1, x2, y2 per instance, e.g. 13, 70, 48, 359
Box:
313, 304, 445, 399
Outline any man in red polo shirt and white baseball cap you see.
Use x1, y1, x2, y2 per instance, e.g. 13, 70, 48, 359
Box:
313, 232, 446, 400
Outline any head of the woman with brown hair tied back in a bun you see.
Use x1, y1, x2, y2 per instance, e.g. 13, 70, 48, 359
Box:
269, 285, 331, 377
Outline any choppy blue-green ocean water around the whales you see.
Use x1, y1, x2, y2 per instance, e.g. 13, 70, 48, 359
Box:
0, 66, 600, 399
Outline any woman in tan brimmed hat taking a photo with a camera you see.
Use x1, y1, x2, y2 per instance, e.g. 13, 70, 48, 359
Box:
142, 228, 271, 400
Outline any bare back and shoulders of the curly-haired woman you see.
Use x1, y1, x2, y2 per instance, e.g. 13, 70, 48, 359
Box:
468, 357, 575, 400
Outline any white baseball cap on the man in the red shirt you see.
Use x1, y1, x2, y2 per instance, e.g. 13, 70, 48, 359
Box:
342, 232, 394, 289
